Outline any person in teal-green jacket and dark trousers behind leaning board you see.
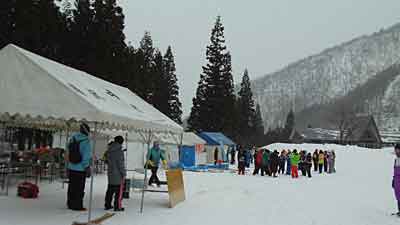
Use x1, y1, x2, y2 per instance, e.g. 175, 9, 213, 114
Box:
146, 142, 167, 187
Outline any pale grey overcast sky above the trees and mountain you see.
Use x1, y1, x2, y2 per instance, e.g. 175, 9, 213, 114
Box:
120, 0, 400, 116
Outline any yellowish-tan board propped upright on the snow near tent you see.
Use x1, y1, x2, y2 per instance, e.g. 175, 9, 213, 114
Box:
166, 169, 185, 208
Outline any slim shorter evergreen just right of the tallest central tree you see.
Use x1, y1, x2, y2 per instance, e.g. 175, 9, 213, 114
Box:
238, 69, 255, 144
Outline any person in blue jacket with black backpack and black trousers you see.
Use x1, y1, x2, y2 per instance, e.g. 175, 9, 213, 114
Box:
67, 123, 92, 211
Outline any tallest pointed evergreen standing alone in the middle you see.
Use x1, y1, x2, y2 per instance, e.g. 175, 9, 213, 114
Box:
188, 16, 235, 136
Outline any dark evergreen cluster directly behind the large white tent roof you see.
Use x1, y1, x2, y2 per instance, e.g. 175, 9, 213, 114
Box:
0, 0, 182, 124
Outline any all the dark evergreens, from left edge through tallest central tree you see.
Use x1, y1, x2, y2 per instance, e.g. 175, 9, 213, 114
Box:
0, 0, 287, 145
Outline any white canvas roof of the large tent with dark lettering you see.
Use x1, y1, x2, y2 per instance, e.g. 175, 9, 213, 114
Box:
0, 44, 183, 133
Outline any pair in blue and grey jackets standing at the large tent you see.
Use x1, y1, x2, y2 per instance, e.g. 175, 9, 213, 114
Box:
67, 123, 126, 211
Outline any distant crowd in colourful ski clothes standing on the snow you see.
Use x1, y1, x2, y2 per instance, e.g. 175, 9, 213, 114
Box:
237, 148, 336, 178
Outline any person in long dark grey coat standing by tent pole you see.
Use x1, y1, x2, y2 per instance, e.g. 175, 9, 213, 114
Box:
104, 136, 126, 211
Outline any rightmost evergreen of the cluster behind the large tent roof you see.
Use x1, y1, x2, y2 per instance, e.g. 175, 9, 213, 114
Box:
159, 46, 182, 124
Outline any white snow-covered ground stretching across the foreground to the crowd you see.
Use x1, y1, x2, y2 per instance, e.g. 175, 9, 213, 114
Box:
0, 144, 400, 225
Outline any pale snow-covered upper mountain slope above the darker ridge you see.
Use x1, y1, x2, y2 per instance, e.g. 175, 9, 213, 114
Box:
252, 24, 400, 127
